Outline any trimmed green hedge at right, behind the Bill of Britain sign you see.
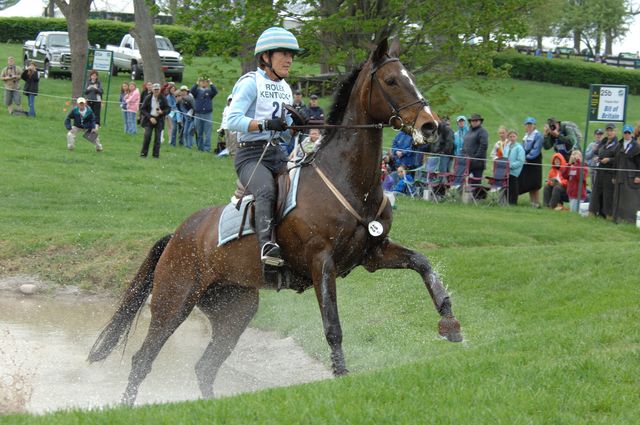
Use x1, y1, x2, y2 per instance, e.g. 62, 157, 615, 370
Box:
493, 52, 640, 94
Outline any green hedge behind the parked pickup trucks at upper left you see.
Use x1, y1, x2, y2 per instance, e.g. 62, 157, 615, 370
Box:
0, 18, 204, 54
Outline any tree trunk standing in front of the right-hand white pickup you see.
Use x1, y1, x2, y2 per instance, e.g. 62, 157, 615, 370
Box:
131, 0, 165, 83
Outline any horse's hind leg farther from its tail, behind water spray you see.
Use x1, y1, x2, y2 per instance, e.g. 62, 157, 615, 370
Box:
196, 285, 259, 398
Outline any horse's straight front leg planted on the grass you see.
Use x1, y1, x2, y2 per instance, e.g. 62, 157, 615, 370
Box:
311, 253, 349, 376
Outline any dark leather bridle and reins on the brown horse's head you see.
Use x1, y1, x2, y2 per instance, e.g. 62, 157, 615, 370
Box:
289, 57, 429, 134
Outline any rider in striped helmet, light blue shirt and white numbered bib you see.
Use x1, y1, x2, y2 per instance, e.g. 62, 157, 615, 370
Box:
227, 27, 302, 266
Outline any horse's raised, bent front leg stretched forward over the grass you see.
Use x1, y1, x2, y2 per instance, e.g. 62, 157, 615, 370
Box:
362, 239, 462, 342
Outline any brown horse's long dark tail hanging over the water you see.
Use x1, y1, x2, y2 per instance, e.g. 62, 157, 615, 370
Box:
88, 235, 173, 363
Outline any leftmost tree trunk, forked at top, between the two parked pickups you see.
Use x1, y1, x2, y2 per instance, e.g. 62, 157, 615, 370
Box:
54, 0, 92, 99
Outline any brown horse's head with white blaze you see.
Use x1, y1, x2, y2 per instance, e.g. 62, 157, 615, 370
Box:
366, 39, 438, 144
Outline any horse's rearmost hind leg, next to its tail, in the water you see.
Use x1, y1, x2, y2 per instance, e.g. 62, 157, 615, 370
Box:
122, 280, 196, 405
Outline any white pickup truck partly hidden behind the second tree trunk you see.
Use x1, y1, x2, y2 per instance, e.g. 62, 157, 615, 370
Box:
106, 34, 184, 82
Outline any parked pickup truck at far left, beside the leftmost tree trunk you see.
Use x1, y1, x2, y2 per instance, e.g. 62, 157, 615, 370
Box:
22, 31, 71, 78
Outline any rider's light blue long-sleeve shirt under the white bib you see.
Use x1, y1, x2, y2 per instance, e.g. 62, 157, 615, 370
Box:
227, 69, 293, 142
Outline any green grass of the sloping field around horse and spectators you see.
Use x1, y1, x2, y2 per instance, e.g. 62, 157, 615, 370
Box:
0, 45, 640, 425
